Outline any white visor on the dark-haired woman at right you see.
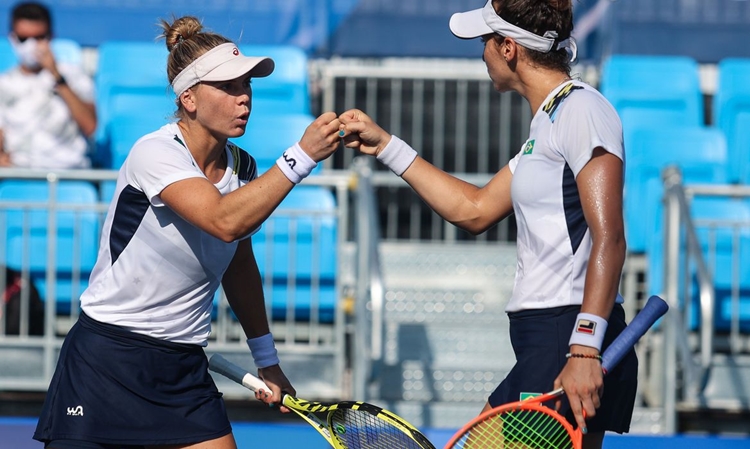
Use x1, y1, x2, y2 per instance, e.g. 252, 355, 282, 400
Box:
449, 0, 577, 61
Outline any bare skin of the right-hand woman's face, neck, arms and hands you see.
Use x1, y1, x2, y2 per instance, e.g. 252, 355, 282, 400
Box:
340, 30, 625, 449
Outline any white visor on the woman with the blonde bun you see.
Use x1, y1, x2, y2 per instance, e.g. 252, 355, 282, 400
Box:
172, 42, 275, 96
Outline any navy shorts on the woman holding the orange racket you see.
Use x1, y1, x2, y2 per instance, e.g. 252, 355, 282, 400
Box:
489, 304, 638, 433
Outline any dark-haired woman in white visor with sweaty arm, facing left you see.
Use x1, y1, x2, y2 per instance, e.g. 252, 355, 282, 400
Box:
340, 0, 638, 448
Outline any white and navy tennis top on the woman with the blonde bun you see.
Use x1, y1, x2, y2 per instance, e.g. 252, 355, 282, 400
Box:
81, 123, 257, 346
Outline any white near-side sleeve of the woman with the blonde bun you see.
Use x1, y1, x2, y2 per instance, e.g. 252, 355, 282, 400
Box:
122, 135, 207, 206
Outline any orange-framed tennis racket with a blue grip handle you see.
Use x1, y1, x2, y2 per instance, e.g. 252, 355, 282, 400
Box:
445, 296, 669, 449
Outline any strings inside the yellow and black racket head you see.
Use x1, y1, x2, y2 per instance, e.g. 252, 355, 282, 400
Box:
329, 409, 424, 449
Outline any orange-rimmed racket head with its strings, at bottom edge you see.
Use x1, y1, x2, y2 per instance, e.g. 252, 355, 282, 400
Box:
445, 395, 583, 449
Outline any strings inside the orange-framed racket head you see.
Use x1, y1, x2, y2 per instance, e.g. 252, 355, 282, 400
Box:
453, 410, 574, 449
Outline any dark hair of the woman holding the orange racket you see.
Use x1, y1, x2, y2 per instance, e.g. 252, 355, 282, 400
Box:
492, 0, 573, 74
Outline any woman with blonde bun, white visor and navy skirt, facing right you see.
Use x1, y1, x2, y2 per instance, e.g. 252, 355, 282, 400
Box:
34, 17, 340, 449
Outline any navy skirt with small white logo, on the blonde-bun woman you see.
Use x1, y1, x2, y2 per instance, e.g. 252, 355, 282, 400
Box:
34, 314, 232, 446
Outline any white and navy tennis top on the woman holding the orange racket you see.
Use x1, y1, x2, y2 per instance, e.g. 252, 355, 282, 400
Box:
506, 81, 625, 312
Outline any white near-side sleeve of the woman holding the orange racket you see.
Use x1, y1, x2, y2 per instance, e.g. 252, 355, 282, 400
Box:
553, 91, 625, 176
